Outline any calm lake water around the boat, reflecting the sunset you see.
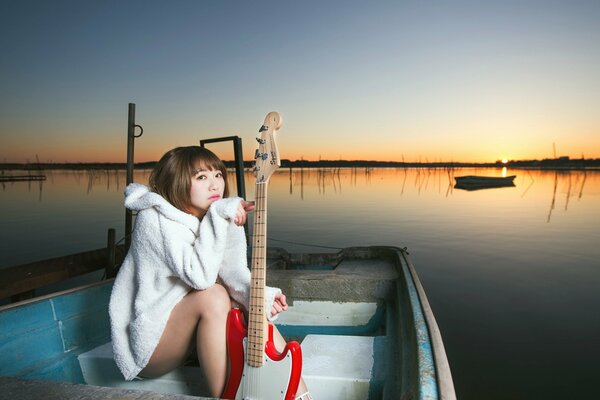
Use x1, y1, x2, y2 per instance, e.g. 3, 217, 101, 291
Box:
0, 169, 600, 399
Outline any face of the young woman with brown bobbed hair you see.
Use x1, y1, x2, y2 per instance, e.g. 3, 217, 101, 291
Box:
188, 168, 225, 217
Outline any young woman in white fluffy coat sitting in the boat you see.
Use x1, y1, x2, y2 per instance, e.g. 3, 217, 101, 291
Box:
109, 146, 306, 397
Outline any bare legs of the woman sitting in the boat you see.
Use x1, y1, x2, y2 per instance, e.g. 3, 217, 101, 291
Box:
142, 284, 231, 397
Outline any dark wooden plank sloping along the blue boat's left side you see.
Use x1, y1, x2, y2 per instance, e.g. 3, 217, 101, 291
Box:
0, 246, 125, 298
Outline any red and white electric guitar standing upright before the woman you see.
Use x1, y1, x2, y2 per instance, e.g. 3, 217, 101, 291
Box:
222, 112, 302, 400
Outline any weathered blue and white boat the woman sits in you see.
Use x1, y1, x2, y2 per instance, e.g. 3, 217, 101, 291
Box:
0, 246, 456, 400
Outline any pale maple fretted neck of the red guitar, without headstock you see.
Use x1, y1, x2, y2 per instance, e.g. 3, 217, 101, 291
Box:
247, 182, 268, 367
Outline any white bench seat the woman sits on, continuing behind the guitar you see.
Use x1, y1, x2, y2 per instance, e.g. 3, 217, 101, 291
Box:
78, 335, 386, 400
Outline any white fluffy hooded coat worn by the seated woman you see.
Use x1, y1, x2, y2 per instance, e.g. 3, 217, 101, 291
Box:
109, 183, 279, 380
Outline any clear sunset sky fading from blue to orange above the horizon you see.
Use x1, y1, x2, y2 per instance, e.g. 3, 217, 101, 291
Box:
0, 0, 600, 162
